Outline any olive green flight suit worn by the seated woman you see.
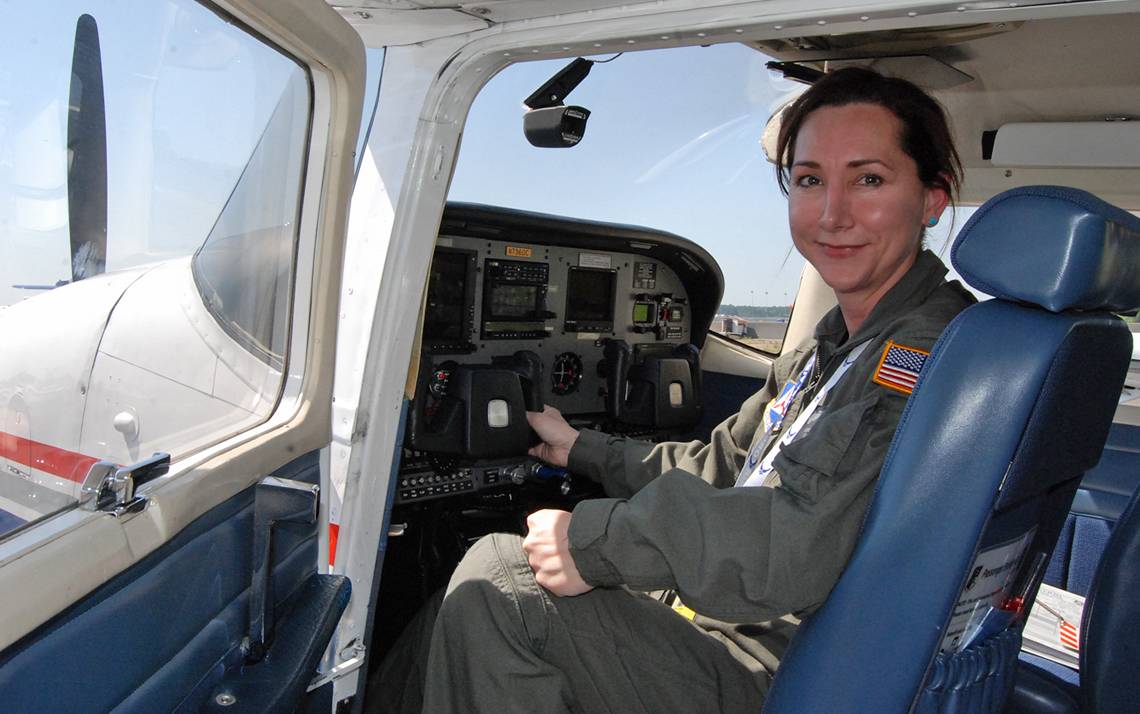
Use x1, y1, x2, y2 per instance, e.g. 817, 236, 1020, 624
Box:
416, 251, 974, 712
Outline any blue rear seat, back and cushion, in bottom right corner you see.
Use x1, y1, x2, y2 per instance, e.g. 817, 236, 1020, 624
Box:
1005, 479, 1140, 714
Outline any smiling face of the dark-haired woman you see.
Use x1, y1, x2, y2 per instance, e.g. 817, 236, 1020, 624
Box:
788, 104, 947, 311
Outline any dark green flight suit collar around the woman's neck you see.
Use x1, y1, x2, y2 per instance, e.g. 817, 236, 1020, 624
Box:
815, 250, 947, 365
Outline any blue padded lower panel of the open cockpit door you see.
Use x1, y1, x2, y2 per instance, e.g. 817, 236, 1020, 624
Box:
0, 453, 319, 712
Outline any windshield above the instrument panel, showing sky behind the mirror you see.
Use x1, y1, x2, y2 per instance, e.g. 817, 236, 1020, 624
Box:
449, 44, 804, 354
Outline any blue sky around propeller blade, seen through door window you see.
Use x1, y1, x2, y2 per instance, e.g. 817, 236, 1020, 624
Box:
0, 0, 302, 306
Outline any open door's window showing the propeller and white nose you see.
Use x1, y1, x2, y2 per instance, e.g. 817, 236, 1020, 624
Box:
0, 0, 311, 537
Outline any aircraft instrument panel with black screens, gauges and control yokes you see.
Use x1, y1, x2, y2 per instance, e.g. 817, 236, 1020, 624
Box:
397, 204, 722, 502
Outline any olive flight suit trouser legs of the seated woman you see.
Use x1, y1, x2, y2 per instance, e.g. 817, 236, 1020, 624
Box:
368, 534, 770, 714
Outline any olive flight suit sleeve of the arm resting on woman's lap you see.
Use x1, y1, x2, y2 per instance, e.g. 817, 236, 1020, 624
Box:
570, 328, 937, 622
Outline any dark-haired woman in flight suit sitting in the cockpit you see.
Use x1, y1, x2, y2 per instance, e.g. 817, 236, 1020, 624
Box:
396, 68, 972, 712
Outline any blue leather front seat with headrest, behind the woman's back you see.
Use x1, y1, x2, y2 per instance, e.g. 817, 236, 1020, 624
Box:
764, 187, 1140, 714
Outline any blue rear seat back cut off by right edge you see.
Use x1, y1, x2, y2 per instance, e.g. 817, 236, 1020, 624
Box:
1081, 481, 1140, 712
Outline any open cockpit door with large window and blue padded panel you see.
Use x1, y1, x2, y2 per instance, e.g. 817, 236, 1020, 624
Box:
0, 0, 365, 712
